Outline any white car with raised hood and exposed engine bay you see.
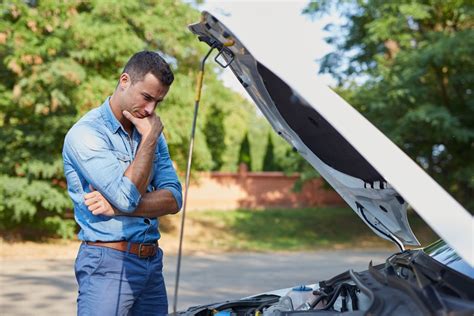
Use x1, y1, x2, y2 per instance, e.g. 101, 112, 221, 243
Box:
179, 12, 474, 315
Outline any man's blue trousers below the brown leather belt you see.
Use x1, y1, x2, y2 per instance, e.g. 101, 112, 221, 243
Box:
75, 243, 168, 316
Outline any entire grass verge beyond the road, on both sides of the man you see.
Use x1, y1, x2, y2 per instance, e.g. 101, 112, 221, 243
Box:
0, 207, 437, 259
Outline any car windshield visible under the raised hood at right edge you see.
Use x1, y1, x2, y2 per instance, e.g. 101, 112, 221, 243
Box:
423, 240, 474, 278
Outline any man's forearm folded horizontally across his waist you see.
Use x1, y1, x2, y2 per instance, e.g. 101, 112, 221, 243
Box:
116, 189, 179, 217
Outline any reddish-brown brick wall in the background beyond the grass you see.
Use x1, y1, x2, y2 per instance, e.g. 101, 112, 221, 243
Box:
187, 165, 344, 210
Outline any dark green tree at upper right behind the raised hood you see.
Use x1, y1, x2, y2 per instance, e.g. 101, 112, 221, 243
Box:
305, 0, 474, 212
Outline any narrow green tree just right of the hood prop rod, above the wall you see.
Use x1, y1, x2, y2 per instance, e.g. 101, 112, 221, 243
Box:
204, 105, 226, 170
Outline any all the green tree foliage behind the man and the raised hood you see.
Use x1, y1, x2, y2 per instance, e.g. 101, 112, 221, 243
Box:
0, 0, 474, 238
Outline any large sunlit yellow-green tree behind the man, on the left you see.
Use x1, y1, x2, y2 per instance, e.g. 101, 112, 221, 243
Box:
0, 0, 260, 237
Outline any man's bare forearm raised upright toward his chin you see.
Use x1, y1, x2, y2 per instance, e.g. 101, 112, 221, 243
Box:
124, 137, 157, 196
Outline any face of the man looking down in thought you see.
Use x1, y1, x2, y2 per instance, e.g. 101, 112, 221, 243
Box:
120, 73, 169, 118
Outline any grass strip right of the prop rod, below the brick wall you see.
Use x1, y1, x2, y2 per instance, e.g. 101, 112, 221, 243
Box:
175, 207, 437, 251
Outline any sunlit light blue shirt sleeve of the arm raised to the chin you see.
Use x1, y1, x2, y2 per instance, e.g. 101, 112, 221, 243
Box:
64, 125, 141, 213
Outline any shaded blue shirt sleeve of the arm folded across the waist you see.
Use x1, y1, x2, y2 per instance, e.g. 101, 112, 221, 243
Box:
152, 134, 183, 210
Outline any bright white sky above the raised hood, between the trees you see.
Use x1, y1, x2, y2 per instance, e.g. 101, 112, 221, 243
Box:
194, 0, 338, 97
